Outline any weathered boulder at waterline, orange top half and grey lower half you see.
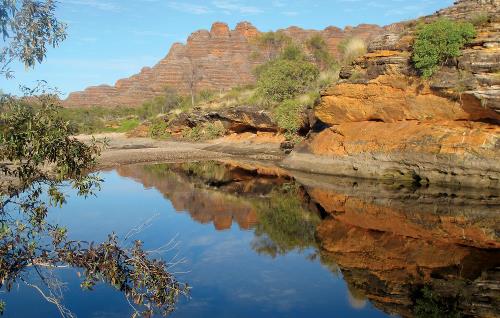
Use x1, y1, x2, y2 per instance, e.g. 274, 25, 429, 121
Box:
282, 121, 500, 188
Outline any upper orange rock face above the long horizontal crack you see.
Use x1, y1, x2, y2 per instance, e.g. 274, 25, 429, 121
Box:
315, 75, 500, 125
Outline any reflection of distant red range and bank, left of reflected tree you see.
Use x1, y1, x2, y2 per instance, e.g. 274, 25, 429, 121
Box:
117, 162, 285, 230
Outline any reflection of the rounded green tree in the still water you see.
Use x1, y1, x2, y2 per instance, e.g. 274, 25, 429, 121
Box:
253, 183, 320, 257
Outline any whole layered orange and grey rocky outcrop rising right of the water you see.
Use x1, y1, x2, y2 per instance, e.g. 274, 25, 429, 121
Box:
283, 0, 500, 188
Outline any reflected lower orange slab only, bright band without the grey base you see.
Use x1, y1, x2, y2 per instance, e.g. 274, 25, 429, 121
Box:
308, 188, 500, 248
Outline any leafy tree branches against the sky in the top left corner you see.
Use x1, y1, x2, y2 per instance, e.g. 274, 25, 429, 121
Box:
0, 0, 66, 77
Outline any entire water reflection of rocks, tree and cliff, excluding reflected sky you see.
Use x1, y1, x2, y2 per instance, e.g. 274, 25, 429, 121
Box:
118, 161, 500, 317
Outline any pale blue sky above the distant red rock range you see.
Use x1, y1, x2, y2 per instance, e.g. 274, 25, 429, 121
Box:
0, 0, 453, 96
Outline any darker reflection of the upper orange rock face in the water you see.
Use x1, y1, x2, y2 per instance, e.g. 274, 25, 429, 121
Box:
317, 219, 469, 281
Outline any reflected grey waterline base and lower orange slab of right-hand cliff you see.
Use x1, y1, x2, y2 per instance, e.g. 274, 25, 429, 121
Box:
295, 175, 500, 248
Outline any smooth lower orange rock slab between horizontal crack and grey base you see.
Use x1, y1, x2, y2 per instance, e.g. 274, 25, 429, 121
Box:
309, 121, 500, 159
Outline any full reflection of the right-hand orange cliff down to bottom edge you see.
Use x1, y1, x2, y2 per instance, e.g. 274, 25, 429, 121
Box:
298, 176, 500, 317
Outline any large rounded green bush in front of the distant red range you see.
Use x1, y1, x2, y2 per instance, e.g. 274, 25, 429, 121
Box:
257, 59, 319, 102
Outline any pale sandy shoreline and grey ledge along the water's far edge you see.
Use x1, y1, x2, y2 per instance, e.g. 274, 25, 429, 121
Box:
83, 133, 499, 192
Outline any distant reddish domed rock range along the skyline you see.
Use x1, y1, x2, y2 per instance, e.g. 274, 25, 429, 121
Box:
64, 22, 382, 107
